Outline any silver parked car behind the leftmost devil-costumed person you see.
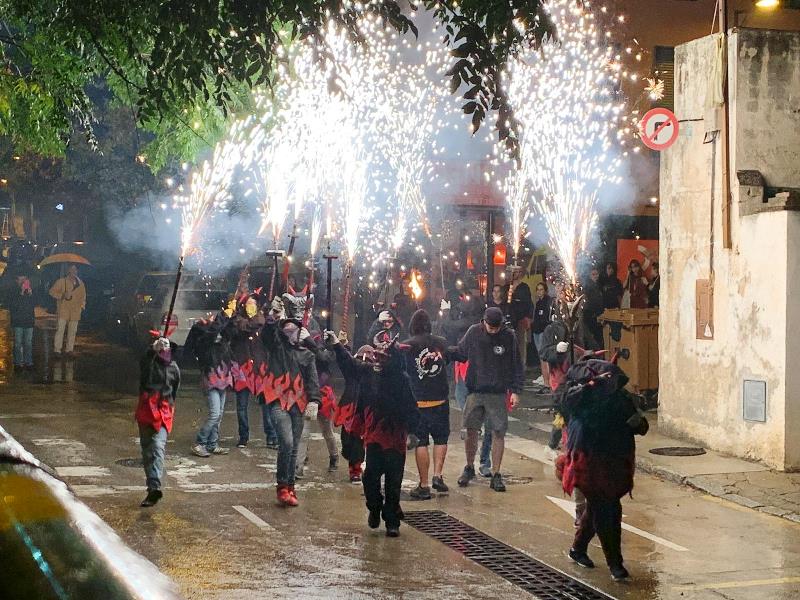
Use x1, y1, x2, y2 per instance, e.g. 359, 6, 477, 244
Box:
133, 286, 228, 346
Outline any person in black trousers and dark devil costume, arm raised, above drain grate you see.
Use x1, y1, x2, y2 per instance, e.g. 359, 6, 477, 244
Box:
325, 331, 419, 537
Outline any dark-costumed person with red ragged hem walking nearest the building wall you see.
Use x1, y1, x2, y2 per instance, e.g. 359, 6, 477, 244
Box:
556, 358, 649, 580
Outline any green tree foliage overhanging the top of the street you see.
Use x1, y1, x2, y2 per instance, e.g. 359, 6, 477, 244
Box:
0, 0, 552, 169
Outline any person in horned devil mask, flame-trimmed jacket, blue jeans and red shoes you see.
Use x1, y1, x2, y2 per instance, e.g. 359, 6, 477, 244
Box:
258, 298, 320, 506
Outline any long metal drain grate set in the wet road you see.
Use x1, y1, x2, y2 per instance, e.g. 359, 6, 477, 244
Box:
405, 510, 613, 600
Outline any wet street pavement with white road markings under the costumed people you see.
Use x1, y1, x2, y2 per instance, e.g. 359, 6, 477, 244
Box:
0, 328, 800, 600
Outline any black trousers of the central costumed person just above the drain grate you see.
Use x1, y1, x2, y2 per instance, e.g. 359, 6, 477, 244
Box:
362, 444, 406, 527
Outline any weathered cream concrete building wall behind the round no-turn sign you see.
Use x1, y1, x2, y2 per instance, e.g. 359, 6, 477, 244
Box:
659, 30, 800, 469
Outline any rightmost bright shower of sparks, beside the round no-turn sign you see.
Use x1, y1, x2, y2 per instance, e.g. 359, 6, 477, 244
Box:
503, 0, 626, 281
